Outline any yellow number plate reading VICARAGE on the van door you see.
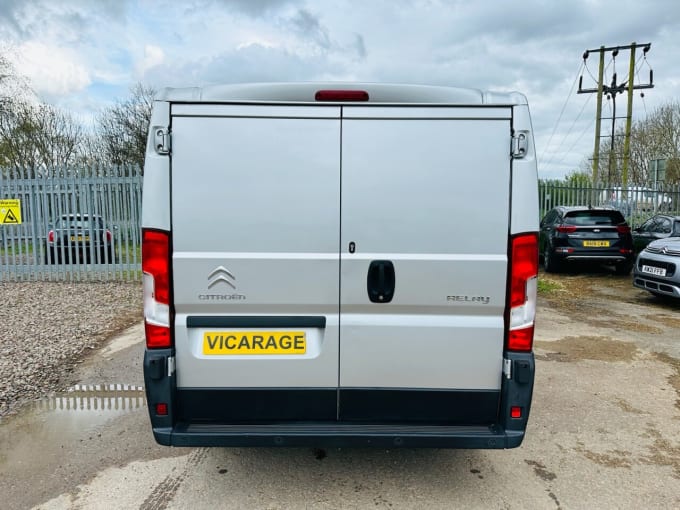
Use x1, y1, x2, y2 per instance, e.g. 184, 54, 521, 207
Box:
203, 331, 307, 355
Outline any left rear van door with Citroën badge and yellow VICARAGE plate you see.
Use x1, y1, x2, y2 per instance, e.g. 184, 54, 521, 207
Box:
171, 104, 340, 423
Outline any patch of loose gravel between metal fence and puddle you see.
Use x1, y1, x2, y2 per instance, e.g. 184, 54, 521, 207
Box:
0, 282, 142, 417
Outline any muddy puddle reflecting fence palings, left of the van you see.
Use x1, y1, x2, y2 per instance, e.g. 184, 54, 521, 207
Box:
0, 384, 146, 472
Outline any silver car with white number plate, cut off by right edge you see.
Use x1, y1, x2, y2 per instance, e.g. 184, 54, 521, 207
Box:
633, 237, 680, 298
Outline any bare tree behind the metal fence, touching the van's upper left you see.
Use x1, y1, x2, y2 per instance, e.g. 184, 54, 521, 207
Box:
94, 83, 156, 168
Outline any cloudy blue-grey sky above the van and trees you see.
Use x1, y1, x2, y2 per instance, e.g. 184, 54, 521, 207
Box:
0, 0, 680, 179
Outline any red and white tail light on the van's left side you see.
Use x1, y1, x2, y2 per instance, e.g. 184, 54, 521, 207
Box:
142, 230, 172, 349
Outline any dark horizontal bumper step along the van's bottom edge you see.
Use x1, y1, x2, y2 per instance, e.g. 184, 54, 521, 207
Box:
154, 423, 524, 448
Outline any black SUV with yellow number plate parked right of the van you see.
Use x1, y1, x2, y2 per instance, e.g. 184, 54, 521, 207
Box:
539, 206, 635, 274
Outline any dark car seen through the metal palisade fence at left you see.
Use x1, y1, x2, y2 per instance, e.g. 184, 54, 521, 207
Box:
45, 214, 115, 264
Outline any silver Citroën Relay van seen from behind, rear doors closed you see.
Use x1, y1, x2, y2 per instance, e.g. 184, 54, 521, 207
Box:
142, 83, 539, 448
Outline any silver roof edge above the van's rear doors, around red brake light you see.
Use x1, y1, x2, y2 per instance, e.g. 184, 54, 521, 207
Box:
156, 82, 527, 106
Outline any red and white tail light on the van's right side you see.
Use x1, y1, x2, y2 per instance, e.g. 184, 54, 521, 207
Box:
506, 233, 538, 352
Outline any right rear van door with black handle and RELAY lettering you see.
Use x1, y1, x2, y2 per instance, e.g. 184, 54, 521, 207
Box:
339, 106, 512, 425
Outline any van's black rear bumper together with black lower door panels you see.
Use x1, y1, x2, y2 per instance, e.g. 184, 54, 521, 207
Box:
144, 349, 535, 449
